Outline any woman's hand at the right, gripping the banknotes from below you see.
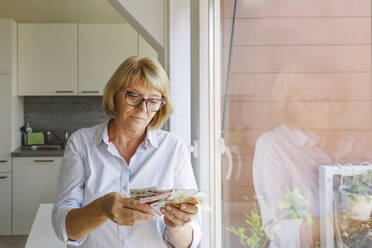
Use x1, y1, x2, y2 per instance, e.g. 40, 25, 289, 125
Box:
161, 203, 198, 228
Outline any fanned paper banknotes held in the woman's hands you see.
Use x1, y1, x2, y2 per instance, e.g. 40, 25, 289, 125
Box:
130, 187, 209, 215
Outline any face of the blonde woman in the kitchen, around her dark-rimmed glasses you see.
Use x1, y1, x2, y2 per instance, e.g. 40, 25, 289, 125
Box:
115, 80, 162, 133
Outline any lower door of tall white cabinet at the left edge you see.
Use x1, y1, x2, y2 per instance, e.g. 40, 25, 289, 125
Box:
0, 173, 12, 235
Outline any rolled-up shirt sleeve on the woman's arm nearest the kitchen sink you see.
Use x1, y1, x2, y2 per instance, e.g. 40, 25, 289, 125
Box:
52, 135, 86, 246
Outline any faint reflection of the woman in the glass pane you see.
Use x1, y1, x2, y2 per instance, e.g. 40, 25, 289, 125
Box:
253, 68, 368, 247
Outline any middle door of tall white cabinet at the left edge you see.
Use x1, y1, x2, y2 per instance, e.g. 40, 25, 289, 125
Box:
0, 74, 11, 172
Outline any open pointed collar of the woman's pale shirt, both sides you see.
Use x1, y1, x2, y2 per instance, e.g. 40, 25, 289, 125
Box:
94, 119, 158, 148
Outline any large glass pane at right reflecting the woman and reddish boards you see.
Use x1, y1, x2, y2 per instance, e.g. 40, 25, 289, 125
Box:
221, 0, 372, 248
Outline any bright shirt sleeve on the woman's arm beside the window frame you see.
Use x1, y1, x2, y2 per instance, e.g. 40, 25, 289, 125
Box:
174, 142, 202, 248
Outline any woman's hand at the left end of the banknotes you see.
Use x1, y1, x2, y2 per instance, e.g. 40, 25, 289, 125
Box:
101, 192, 155, 226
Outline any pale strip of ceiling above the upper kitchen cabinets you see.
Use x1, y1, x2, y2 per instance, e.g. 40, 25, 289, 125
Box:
0, 0, 126, 23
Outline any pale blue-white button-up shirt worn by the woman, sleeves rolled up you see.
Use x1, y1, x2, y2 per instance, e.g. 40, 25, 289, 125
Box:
52, 120, 201, 248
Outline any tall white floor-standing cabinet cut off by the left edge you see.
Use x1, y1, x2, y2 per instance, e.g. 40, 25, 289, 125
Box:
0, 19, 23, 235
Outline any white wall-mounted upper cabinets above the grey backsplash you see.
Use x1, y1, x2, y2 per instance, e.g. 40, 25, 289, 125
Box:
18, 23, 158, 96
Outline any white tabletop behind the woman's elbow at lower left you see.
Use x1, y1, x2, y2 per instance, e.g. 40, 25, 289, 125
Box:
25, 203, 67, 248
